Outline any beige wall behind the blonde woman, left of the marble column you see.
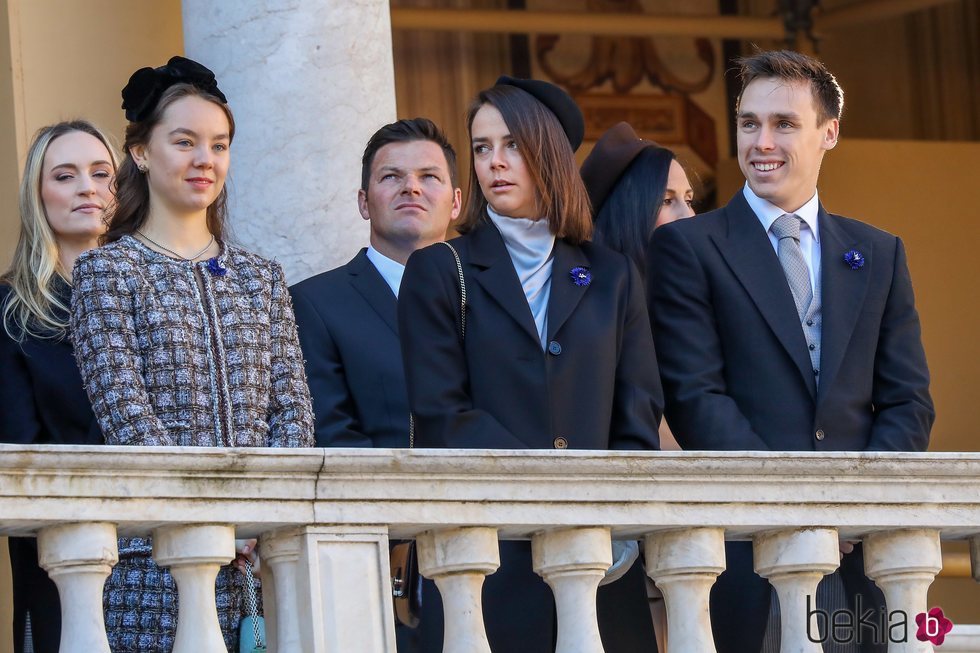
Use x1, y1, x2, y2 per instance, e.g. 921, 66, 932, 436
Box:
0, 0, 184, 268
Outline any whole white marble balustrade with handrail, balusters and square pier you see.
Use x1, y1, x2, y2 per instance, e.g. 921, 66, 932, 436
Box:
0, 445, 980, 653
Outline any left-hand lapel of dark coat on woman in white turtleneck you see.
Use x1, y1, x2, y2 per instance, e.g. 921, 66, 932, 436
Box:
469, 221, 541, 347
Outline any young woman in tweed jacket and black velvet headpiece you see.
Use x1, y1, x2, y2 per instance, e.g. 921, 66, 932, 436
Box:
71, 57, 313, 653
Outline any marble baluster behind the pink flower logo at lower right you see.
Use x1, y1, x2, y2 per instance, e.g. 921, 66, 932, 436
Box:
864, 528, 943, 653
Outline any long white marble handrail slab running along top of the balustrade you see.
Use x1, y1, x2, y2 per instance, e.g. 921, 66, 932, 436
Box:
0, 445, 980, 538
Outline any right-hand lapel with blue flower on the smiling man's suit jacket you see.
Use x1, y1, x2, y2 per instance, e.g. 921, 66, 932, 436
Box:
817, 206, 874, 398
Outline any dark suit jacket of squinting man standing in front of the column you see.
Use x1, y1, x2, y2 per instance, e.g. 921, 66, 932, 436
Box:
290, 249, 409, 447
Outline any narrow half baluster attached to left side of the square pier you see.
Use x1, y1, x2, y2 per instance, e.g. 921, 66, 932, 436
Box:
259, 529, 303, 653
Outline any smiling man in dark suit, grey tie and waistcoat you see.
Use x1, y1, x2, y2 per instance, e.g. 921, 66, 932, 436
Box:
649, 52, 934, 653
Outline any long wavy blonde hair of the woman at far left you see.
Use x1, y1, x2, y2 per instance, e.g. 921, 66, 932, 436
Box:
0, 120, 117, 342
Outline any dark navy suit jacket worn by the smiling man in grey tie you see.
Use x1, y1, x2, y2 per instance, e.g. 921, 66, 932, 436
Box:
648, 191, 934, 653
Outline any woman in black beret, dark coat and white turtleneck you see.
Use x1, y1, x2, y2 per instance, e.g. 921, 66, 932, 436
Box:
398, 77, 663, 653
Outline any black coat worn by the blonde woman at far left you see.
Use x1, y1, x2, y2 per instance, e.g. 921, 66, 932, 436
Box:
0, 278, 103, 653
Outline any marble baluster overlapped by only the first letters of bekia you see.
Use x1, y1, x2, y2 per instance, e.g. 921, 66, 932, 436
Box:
753, 528, 840, 653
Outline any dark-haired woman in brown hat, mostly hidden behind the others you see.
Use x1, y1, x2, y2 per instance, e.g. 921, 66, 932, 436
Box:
582, 122, 694, 274
